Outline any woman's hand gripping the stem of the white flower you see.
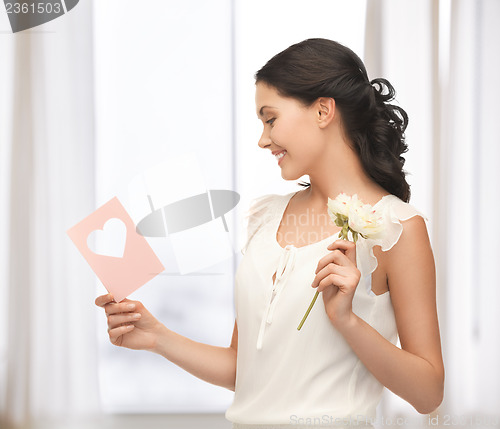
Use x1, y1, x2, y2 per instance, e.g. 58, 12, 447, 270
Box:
312, 239, 361, 326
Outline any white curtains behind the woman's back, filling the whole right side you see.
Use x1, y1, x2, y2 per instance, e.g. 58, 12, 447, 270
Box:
365, 0, 500, 426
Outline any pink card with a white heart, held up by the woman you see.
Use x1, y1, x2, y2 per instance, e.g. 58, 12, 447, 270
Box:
66, 197, 165, 302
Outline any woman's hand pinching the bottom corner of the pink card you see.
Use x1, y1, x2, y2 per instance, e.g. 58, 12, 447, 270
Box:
95, 294, 165, 352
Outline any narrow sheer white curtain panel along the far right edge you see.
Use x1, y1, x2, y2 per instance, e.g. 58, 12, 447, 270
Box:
440, 0, 500, 414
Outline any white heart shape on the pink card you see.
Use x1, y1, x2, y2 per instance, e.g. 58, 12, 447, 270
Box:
87, 217, 127, 258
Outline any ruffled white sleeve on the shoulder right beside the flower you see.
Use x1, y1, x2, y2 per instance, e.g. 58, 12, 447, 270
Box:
356, 195, 429, 292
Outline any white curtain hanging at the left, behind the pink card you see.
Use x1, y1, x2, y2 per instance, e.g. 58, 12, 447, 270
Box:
0, 1, 99, 427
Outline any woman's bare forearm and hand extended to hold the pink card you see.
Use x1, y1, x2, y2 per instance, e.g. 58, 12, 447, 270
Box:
96, 294, 238, 391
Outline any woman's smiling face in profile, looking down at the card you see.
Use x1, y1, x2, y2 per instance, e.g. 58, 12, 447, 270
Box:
255, 82, 326, 180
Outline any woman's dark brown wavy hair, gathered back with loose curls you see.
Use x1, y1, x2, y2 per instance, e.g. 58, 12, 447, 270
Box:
255, 38, 410, 202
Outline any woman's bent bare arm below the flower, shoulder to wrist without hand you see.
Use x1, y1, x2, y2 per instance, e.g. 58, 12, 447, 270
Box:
335, 216, 444, 414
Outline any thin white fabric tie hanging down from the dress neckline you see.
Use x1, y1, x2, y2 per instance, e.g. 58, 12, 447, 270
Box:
257, 244, 297, 350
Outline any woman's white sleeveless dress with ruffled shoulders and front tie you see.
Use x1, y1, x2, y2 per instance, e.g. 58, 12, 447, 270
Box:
225, 191, 428, 429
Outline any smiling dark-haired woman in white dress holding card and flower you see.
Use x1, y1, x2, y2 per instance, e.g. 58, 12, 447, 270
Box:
96, 39, 444, 428
